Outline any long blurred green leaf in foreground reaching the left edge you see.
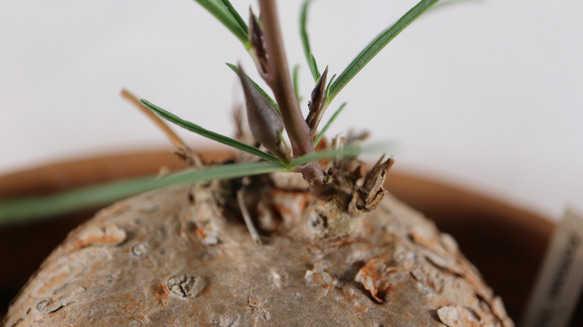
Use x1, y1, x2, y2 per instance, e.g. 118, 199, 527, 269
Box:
0, 161, 288, 225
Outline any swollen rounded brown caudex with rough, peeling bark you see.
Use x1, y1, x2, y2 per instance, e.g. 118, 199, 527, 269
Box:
6, 170, 512, 326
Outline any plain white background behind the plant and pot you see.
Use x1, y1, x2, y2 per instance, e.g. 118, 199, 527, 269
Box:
0, 0, 583, 219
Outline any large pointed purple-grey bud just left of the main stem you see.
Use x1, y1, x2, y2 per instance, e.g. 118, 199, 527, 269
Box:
239, 66, 283, 153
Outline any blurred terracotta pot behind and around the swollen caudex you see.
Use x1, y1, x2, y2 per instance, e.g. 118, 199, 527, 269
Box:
0, 151, 583, 326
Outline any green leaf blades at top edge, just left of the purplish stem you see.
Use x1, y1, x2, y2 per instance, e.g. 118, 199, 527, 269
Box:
195, 0, 251, 49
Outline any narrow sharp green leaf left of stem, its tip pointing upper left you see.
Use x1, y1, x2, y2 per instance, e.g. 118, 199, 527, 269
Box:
140, 99, 282, 164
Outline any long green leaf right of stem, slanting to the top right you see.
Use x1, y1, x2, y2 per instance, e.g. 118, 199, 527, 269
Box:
327, 0, 439, 103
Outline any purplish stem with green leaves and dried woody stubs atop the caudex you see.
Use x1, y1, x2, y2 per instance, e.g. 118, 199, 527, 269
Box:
0, 0, 438, 229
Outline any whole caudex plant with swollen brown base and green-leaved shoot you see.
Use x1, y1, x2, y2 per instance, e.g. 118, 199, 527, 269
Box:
6, 0, 556, 326
